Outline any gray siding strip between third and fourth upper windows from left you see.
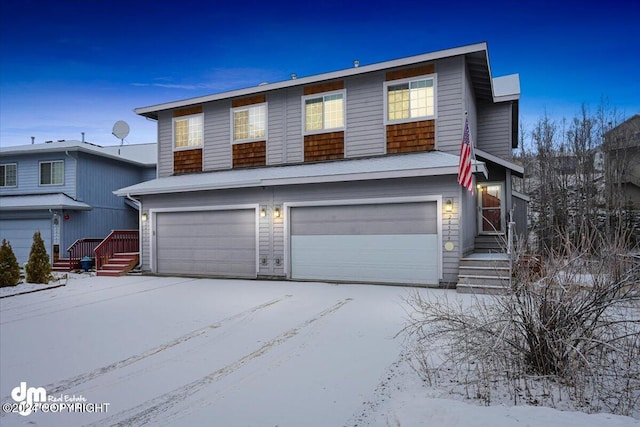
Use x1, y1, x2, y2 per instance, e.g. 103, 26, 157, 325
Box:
345, 72, 386, 157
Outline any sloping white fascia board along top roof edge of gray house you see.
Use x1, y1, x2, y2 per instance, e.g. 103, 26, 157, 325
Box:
133, 42, 489, 117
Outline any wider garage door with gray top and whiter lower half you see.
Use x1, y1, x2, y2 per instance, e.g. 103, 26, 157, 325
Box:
290, 202, 439, 284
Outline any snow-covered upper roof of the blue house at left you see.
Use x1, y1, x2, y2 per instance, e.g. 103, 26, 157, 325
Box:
0, 140, 158, 166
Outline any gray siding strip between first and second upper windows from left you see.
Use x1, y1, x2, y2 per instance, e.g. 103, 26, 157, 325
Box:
202, 100, 231, 171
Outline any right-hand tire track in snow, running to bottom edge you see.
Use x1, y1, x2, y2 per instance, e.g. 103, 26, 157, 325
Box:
88, 298, 352, 427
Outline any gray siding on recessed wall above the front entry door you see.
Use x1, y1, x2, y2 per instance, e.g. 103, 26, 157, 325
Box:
477, 103, 512, 160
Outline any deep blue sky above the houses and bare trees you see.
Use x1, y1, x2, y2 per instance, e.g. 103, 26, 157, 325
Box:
0, 0, 640, 146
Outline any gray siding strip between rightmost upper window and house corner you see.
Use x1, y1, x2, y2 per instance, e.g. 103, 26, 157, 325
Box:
436, 57, 464, 155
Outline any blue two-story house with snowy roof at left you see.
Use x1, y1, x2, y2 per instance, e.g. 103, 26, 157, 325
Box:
0, 141, 157, 264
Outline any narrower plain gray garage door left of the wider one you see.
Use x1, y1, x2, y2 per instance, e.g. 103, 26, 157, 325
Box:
155, 209, 256, 278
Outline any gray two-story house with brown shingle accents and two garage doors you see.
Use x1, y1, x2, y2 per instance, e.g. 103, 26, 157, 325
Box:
116, 43, 526, 286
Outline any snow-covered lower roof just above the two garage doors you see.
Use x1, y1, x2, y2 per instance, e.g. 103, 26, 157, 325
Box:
114, 151, 486, 196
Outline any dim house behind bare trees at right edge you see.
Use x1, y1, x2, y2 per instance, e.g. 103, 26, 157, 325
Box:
604, 114, 640, 210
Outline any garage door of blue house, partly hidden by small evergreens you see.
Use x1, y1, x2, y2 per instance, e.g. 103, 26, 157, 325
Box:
0, 219, 51, 265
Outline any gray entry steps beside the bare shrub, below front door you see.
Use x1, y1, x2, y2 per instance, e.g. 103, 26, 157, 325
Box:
456, 252, 511, 294
